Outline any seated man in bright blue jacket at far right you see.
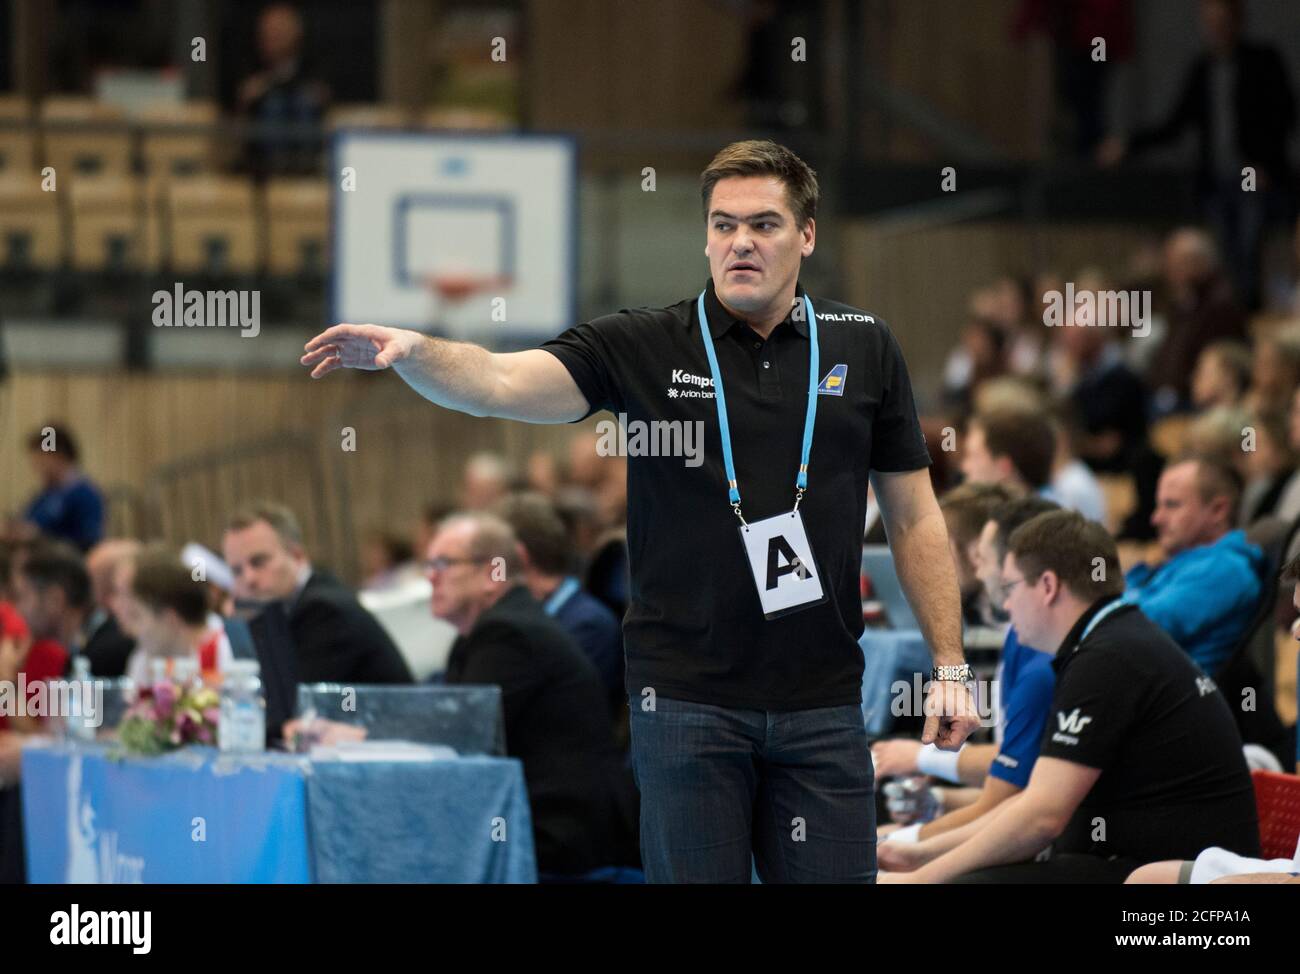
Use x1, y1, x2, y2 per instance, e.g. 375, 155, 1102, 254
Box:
1123, 458, 1264, 676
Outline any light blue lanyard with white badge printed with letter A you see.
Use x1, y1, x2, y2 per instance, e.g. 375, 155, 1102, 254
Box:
697, 291, 826, 619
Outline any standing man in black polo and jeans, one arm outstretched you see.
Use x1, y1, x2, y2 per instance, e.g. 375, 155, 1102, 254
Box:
303, 142, 978, 882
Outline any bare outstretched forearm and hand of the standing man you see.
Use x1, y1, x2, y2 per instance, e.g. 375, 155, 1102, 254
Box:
302, 324, 589, 423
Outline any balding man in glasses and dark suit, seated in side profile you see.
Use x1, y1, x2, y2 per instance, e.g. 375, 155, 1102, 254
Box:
428, 514, 640, 874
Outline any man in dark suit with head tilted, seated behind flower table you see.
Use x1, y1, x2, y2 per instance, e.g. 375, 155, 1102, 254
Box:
222, 503, 411, 684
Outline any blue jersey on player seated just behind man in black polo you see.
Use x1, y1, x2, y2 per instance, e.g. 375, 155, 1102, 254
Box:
988, 625, 1056, 788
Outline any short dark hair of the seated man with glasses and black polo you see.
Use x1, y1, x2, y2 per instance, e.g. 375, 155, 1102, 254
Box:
1006, 511, 1125, 603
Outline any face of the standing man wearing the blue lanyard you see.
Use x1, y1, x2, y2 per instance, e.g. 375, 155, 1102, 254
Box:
705, 176, 816, 316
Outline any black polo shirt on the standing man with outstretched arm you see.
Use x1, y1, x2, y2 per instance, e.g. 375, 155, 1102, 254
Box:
542, 273, 930, 710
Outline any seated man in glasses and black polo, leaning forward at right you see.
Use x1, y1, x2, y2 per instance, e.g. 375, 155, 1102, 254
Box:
881, 511, 1260, 883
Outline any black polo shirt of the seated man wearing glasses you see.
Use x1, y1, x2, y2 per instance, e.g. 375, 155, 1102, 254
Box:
1039, 599, 1260, 862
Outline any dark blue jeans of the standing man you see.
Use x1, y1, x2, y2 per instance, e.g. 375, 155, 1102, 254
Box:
631, 697, 876, 883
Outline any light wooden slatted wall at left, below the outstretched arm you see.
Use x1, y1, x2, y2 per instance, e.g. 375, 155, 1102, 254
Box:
0, 372, 594, 571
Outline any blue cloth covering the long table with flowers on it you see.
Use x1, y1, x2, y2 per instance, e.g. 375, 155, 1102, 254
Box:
22, 743, 537, 883
